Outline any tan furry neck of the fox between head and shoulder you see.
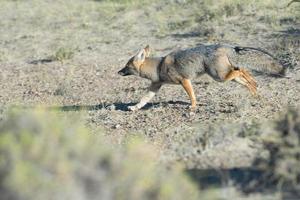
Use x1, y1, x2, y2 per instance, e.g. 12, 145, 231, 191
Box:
140, 57, 163, 82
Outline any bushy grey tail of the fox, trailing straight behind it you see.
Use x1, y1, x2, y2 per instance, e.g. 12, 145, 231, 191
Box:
229, 46, 286, 77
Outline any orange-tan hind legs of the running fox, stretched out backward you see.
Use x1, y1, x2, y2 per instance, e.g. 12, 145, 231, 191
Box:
225, 69, 257, 95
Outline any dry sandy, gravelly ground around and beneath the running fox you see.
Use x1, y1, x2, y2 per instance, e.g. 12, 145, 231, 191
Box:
0, 0, 300, 198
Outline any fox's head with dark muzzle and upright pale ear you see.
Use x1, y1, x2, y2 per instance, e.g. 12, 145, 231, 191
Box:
118, 45, 150, 76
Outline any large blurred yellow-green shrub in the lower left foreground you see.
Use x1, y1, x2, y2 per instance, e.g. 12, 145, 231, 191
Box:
0, 110, 199, 200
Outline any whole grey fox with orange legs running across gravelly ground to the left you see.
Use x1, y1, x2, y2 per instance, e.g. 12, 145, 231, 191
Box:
118, 44, 285, 111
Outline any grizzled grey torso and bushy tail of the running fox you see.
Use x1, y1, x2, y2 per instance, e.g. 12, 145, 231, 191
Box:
163, 44, 285, 81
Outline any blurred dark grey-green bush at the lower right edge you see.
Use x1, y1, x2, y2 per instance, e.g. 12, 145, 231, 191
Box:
254, 109, 300, 191
